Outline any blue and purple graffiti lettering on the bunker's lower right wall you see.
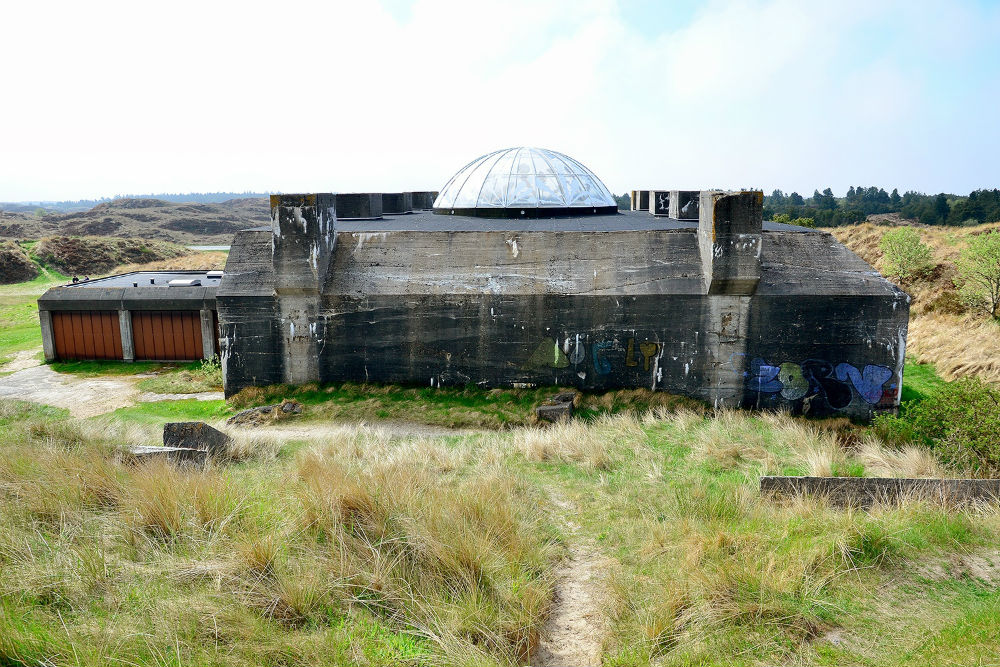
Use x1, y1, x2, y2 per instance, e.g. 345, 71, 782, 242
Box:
743, 359, 896, 410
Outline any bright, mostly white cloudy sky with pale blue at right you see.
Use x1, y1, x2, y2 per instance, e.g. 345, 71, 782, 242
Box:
0, 0, 1000, 201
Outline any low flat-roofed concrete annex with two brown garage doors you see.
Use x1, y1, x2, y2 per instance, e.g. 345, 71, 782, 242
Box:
38, 271, 222, 361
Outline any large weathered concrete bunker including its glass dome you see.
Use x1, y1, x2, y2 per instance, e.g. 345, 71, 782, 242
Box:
216, 148, 909, 418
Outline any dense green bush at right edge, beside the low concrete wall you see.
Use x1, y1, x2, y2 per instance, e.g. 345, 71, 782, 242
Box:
875, 378, 1000, 476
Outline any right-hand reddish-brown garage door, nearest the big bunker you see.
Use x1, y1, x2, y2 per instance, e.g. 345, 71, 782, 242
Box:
132, 310, 202, 361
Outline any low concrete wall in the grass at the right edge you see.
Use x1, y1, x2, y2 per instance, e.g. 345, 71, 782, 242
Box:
760, 477, 1000, 506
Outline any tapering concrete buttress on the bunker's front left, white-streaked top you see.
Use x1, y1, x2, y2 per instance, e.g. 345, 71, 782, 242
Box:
271, 194, 337, 384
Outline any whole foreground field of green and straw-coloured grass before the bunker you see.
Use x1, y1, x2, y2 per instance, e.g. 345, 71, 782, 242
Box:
0, 401, 1000, 665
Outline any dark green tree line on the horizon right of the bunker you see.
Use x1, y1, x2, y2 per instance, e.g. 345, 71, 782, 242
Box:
764, 186, 1000, 227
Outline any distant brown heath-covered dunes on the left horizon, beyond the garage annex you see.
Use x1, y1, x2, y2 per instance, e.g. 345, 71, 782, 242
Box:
0, 198, 270, 245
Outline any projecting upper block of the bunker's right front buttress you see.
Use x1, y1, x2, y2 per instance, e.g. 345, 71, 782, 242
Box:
698, 190, 764, 295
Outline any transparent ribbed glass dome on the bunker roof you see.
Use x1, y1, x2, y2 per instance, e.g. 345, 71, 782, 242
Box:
434, 148, 618, 218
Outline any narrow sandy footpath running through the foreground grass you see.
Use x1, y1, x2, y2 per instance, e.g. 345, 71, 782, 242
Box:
531, 499, 607, 667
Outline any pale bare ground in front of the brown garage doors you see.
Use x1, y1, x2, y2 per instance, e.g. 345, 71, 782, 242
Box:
0, 350, 222, 417
